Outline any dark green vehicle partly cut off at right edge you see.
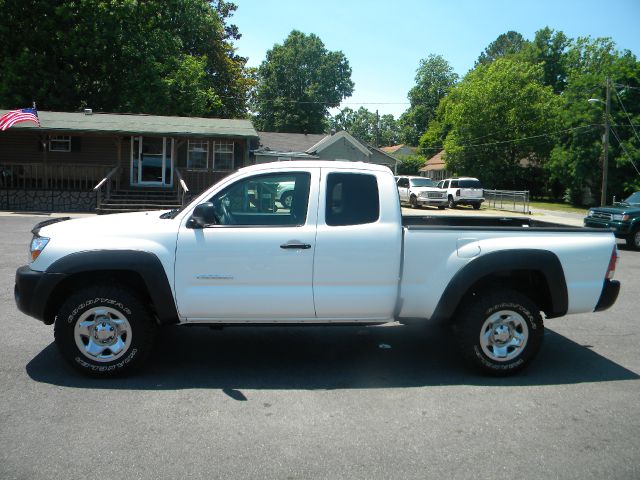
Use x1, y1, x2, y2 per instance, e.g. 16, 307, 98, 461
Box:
584, 192, 640, 250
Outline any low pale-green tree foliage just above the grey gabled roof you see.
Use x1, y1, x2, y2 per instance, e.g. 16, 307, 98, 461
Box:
329, 107, 399, 146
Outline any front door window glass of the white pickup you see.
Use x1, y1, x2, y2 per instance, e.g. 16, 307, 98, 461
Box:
209, 172, 311, 226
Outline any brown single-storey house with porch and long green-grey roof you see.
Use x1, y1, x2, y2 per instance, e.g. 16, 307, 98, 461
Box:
0, 109, 258, 212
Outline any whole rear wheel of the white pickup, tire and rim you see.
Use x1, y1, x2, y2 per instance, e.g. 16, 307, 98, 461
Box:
454, 286, 544, 376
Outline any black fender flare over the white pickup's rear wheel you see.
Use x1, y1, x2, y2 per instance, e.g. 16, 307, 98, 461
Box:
431, 249, 569, 320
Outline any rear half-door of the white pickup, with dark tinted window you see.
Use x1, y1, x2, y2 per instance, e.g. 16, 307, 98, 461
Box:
313, 168, 402, 321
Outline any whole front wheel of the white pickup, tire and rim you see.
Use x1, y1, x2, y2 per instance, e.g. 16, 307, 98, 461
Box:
54, 285, 156, 377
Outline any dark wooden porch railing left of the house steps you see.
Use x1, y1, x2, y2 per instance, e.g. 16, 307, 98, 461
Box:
0, 161, 113, 192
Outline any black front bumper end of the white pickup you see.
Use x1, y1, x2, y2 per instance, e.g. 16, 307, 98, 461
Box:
13, 265, 66, 325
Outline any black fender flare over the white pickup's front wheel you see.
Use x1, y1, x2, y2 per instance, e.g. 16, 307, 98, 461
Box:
46, 250, 178, 325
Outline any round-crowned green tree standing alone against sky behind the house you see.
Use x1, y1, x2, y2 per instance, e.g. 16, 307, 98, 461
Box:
254, 30, 353, 133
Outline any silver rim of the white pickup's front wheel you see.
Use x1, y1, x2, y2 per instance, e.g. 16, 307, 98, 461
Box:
73, 306, 132, 362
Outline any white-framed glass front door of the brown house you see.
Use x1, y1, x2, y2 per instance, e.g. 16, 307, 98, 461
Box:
131, 137, 174, 187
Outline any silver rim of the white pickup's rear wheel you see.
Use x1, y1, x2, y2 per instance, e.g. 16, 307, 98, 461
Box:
480, 310, 529, 362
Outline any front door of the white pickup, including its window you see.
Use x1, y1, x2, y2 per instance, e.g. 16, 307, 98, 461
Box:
175, 168, 319, 322
